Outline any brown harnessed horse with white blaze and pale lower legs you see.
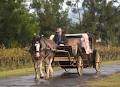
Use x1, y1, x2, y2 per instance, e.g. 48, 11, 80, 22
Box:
30, 36, 57, 79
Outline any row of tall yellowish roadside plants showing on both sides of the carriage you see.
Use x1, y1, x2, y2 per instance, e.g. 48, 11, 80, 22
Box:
0, 46, 120, 71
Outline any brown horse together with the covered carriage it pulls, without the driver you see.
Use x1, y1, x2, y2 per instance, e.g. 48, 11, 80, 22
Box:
29, 33, 101, 79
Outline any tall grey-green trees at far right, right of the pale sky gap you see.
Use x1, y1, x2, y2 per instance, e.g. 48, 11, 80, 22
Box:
81, 0, 120, 45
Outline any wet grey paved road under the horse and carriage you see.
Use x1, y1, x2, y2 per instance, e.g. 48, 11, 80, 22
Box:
0, 64, 120, 87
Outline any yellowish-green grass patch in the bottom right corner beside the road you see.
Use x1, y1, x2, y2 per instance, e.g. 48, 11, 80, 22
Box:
87, 73, 120, 87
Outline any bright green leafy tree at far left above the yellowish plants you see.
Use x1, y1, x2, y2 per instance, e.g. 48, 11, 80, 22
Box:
0, 0, 37, 47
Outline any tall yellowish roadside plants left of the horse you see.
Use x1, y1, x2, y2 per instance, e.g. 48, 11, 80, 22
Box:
0, 48, 33, 70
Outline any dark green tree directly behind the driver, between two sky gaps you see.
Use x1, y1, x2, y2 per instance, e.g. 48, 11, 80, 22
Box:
31, 0, 69, 36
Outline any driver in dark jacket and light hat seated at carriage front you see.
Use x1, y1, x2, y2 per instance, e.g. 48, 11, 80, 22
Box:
53, 28, 67, 45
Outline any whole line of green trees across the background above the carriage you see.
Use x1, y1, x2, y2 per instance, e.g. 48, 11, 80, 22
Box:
0, 0, 120, 48
